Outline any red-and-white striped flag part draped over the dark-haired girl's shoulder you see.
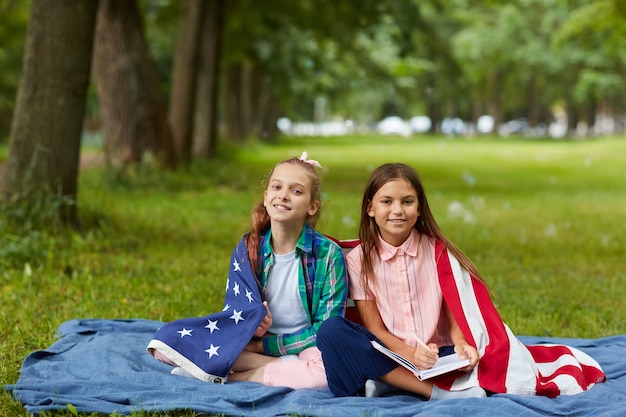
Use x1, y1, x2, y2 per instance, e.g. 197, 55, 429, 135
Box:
433, 242, 606, 397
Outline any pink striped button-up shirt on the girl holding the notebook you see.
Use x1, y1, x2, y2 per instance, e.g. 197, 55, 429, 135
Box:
346, 230, 453, 346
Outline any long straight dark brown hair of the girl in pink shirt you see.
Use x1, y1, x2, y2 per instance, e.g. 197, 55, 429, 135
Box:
359, 163, 482, 288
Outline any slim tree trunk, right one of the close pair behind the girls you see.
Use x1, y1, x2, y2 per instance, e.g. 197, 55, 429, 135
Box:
193, 0, 224, 159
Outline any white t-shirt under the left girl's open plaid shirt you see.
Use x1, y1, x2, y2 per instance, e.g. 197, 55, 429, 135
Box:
265, 249, 311, 334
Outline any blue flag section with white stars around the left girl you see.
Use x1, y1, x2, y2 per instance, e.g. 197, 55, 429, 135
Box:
147, 239, 267, 384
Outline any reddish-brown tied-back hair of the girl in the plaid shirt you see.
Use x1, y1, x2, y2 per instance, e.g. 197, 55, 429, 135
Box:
246, 158, 322, 274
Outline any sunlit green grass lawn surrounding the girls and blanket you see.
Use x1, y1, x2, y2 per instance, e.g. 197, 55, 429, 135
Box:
0, 137, 626, 416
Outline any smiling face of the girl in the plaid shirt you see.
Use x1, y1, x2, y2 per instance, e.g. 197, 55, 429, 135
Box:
263, 163, 320, 227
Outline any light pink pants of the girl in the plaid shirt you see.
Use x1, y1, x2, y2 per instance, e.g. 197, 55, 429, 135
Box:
263, 347, 328, 389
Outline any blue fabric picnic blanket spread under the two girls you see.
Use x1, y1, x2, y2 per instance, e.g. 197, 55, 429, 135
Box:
4, 319, 626, 417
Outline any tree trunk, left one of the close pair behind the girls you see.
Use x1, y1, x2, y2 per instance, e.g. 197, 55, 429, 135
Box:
170, 0, 202, 164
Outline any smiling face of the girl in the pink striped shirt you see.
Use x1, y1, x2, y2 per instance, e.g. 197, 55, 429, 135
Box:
367, 179, 420, 246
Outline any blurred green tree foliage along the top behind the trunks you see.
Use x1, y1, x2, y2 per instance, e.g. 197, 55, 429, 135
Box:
0, 0, 626, 135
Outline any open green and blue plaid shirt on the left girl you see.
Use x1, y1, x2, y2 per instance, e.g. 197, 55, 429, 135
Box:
259, 223, 348, 356
